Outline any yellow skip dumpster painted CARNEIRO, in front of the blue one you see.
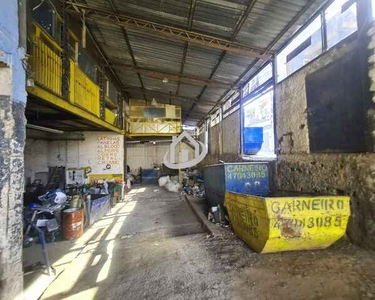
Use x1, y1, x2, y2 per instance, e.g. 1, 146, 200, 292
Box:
224, 191, 350, 253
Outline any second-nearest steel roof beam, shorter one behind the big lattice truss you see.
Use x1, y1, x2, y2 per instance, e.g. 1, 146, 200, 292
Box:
106, 64, 232, 87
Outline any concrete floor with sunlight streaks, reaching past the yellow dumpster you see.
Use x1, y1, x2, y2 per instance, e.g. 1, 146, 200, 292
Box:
42, 187, 375, 300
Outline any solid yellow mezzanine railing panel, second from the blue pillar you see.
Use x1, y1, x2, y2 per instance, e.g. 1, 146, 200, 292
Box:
69, 60, 100, 117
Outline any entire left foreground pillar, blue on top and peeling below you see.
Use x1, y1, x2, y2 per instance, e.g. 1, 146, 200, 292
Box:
0, 0, 26, 299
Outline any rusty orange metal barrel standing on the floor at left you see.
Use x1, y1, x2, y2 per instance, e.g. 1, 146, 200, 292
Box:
63, 208, 83, 240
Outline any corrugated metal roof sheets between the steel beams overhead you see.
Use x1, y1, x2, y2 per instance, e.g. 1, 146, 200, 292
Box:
81, 0, 324, 125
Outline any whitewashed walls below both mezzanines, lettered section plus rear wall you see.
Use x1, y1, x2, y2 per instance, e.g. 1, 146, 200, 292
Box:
25, 131, 200, 182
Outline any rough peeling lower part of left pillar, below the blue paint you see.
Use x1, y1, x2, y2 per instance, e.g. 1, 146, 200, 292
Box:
0, 82, 25, 299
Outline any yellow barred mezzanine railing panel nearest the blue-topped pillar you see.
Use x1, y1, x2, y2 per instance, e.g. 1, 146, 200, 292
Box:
30, 23, 62, 96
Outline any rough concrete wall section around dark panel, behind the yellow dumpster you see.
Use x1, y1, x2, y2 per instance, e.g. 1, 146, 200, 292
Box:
275, 34, 375, 249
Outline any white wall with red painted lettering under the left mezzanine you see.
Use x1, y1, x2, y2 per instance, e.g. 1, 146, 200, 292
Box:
25, 131, 124, 182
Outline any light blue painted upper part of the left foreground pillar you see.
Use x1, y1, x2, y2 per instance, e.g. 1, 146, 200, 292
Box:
0, 0, 26, 103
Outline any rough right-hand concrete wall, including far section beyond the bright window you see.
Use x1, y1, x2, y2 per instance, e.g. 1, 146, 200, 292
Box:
199, 28, 375, 249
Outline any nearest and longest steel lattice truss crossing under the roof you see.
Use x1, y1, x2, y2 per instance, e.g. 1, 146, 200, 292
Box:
67, 1, 272, 60
